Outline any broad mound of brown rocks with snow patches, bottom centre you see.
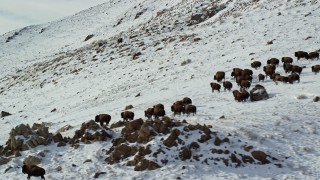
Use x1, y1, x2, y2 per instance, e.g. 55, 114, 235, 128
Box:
105, 117, 281, 171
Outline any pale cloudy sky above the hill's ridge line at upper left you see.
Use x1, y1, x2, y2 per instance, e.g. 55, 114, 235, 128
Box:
0, 0, 108, 34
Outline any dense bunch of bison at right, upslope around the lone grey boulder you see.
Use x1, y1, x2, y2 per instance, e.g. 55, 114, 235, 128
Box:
210, 51, 320, 102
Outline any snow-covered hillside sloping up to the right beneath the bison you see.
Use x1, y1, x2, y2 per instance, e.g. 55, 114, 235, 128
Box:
0, 0, 320, 179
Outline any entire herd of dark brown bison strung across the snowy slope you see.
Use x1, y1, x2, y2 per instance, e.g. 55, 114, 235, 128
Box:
22, 51, 320, 179
